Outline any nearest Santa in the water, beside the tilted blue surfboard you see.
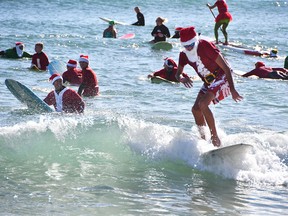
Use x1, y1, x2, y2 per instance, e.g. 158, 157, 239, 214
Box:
44, 74, 85, 113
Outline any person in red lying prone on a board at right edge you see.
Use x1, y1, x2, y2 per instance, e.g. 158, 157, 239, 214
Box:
242, 62, 288, 80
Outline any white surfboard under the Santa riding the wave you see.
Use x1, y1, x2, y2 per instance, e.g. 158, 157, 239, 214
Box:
201, 143, 253, 164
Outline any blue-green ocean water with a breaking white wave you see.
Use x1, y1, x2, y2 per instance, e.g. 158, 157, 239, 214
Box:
0, 0, 288, 215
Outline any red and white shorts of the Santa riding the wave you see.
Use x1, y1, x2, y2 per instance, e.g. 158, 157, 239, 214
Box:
200, 75, 231, 104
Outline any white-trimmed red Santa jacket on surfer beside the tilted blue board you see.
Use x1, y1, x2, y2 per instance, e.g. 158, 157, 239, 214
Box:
44, 87, 85, 113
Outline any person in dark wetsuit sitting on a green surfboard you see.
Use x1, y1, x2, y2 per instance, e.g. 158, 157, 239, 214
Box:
150, 17, 170, 43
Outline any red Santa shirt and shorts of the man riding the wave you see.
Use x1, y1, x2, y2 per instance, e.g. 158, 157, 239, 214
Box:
179, 40, 230, 104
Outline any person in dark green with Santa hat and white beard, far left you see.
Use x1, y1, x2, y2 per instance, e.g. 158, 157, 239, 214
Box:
0, 42, 32, 59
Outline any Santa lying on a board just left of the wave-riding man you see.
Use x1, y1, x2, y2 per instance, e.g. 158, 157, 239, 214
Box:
148, 58, 188, 82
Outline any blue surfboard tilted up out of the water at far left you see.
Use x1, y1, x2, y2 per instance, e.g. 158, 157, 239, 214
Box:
5, 79, 54, 113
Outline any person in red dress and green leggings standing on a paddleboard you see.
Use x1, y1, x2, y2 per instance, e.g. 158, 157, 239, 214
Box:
207, 0, 232, 45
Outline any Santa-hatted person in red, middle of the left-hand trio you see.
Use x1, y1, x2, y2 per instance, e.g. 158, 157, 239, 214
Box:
62, 59, 82, 85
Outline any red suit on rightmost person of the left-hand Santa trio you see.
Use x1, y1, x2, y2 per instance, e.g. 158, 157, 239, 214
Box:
81, 67, 98, 97
